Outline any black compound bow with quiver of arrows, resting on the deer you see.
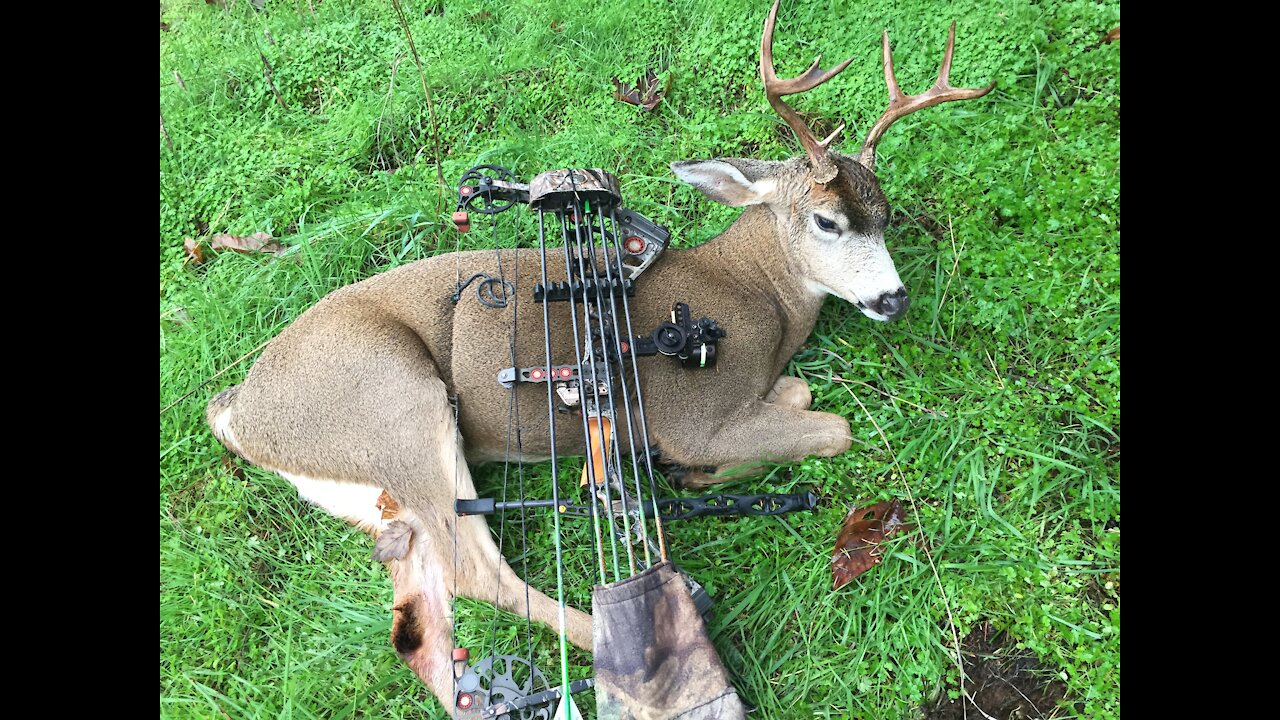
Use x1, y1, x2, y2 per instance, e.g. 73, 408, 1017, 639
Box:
452, 165, 817, 720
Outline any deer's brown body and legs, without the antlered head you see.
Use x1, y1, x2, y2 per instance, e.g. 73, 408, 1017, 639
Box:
207, 178, 850, 697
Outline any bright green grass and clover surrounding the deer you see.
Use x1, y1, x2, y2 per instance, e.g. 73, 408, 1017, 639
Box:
160, 0, 1120, 719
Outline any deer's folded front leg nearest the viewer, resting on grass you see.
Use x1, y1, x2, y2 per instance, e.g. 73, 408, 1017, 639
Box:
663, 397, 852, 487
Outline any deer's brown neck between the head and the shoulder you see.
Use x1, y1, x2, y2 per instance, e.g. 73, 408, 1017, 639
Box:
695, 205, 827, 369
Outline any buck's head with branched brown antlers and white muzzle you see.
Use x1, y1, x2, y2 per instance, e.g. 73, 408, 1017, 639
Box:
671, 0, 995, 320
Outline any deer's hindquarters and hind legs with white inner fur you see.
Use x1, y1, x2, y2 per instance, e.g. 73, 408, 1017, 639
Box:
207, 317, 591, 708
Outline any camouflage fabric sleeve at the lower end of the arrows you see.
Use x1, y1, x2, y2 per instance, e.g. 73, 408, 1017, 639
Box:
591, 562, 746, 720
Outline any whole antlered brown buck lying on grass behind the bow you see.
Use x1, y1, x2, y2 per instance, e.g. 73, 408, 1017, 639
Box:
206, 0, 995, 707
